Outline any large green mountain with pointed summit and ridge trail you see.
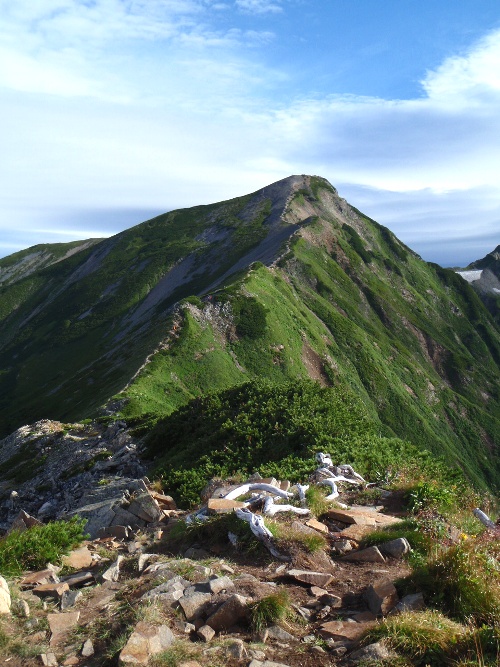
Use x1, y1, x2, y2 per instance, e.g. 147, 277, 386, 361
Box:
0, 176, 500, 487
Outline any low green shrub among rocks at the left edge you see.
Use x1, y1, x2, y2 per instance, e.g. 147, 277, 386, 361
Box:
0, 517, 85, 575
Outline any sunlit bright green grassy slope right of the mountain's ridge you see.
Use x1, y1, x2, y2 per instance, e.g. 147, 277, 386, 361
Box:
118, 180, 500, 485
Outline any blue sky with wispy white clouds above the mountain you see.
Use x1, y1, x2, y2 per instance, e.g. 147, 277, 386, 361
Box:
0, 0, 500, 266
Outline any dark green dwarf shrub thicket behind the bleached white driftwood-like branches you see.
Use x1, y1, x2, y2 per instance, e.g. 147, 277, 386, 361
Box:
146, 380, 472, 504
